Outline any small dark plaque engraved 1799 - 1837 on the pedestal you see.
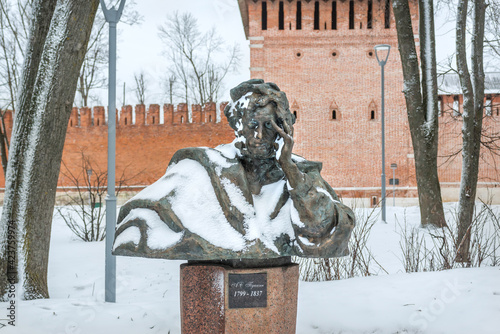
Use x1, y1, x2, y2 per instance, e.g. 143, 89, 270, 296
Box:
228, 273, 267, 308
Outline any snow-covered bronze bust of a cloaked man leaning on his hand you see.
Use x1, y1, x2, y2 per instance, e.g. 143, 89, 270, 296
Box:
113, 79, 354, 260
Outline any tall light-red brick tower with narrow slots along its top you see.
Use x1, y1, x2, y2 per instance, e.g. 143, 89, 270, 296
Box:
238, 0, 418, 200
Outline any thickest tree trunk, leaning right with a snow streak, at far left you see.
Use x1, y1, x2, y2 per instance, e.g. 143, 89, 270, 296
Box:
1, 0, 99, 299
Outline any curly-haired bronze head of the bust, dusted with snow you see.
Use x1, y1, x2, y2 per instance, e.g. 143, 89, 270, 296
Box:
224, 79, 295, 159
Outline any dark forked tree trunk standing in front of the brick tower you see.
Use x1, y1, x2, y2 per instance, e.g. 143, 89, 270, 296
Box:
393, 0, 446, 227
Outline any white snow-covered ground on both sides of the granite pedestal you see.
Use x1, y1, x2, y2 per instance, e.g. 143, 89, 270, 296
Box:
0, 207, 500, 334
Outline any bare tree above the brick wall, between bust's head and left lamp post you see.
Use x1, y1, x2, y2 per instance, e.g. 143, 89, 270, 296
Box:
159, 12, 241, 104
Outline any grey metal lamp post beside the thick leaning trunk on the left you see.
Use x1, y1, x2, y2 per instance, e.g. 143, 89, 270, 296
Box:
101, 0, 125, 303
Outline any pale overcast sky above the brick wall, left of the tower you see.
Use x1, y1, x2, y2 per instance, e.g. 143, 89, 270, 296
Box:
100, 0, 455, 105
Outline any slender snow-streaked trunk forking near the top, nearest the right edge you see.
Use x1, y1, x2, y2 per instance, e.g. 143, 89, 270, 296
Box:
456, 0, 486, 262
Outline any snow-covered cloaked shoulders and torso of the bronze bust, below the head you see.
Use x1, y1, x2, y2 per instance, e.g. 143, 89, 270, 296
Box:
113, 141, 354, 260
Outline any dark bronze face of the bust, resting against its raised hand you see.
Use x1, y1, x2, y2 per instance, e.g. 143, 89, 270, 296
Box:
242, 103, 278, 159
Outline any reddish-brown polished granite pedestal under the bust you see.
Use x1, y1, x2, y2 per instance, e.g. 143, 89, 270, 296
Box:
180, 263, 299, 334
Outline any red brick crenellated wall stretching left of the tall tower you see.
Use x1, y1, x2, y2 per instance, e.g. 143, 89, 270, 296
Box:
0, 103, 234, 187
